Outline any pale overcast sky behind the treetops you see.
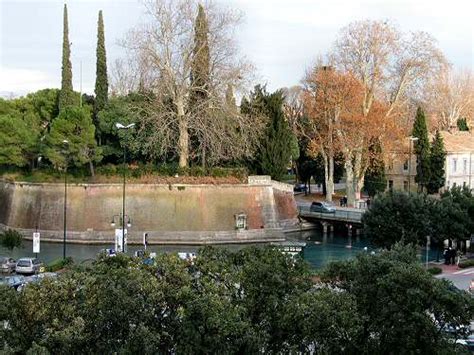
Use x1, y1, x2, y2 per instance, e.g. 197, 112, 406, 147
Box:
0, 0, 474, 96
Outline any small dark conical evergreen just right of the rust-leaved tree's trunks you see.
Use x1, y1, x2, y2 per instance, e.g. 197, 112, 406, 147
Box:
364, 139, 387, 197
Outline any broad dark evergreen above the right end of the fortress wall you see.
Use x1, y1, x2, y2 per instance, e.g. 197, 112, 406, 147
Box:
259, 91, 292, 180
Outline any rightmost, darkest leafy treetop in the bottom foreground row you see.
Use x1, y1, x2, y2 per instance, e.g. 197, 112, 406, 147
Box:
322, 245, 474, 354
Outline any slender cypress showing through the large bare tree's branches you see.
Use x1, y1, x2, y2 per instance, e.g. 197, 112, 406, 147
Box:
190, 4, 210, 167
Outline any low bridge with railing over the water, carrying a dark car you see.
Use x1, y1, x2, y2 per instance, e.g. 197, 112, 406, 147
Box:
297, 203, 365, 225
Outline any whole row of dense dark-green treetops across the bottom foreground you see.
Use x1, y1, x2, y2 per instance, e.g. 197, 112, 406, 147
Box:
0, 246, 473, 354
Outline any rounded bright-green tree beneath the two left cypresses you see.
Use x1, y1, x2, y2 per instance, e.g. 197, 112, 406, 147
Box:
45, 107, 101, 169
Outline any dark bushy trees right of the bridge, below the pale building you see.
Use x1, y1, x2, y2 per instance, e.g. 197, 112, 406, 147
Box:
362, 188, 474, 248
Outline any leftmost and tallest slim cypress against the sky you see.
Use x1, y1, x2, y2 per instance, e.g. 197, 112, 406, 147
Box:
59, 4, 75, 110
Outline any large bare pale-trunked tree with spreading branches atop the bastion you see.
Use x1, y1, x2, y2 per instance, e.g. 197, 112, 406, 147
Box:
116, 0, 259, 167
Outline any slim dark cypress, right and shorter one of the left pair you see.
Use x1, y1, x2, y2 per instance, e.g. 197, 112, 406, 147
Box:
94, 10, 109, 121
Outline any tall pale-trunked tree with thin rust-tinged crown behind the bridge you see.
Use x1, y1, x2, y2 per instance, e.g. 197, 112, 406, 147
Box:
332, 20, 446, 200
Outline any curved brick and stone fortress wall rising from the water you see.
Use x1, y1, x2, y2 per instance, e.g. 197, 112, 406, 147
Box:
0, 176, 298, 244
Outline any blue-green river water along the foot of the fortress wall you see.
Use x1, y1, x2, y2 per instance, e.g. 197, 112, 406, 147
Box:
0, 230, 436, 268
